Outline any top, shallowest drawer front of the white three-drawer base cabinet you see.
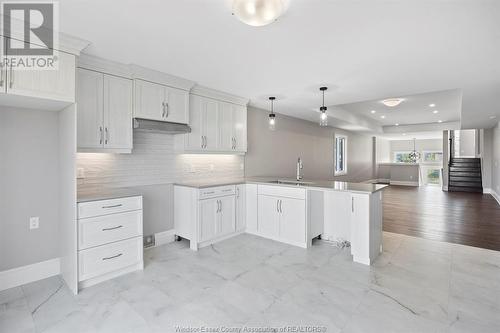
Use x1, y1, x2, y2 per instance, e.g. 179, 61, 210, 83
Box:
78, 196, 142, 219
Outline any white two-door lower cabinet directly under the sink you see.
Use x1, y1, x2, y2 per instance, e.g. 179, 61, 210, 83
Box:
257, 185, 307, 247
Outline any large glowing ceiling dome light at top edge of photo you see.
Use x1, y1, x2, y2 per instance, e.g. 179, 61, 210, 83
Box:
233, 0, 285, 27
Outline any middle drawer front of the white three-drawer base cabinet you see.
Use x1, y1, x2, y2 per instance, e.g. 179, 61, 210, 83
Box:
78, 210, 142, 250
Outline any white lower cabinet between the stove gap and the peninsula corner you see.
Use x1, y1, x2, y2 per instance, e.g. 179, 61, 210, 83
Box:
174, 185, 240, 250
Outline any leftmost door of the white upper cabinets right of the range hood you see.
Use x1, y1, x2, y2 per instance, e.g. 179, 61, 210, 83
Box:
185, 95, 205, 151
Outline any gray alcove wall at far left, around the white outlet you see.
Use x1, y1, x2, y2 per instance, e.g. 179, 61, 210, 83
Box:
0, 107, 59, 271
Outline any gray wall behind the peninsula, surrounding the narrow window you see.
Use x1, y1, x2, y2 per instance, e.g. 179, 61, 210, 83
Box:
245, 107, 374, 181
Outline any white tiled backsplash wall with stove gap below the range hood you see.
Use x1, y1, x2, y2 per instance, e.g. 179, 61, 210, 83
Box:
77, 131, 244, 235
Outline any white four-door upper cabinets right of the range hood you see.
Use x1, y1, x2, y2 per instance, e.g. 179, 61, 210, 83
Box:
178, 87, 247, 154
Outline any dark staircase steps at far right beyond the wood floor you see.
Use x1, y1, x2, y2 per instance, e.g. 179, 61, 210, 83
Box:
448, 157, 483, 193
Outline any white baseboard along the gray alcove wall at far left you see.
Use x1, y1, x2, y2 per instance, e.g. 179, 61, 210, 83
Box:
0, 258, 61, 291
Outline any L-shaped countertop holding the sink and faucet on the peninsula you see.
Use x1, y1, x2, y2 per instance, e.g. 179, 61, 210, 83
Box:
175, 177, 387, 193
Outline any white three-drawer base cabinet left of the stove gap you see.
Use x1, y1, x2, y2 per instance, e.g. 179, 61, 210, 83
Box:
77, 196, 143, 289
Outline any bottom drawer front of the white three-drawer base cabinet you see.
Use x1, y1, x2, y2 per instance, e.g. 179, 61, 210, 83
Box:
78, 237, 142, 281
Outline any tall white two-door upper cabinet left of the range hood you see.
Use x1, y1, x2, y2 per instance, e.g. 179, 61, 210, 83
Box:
76, 68, 132, 153
